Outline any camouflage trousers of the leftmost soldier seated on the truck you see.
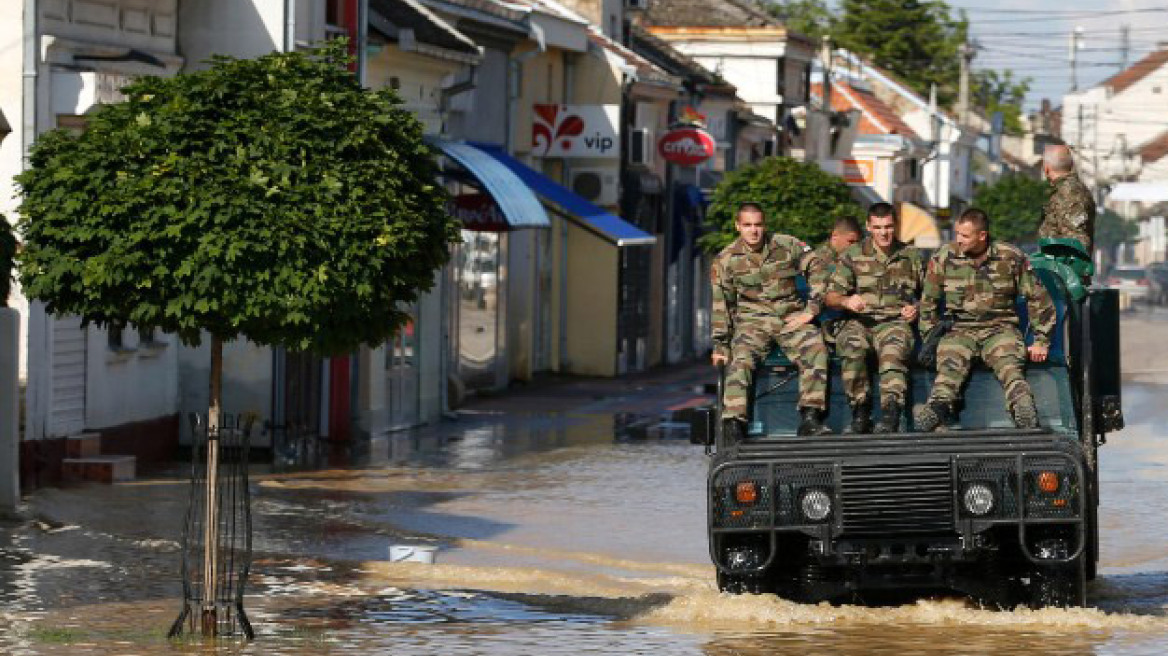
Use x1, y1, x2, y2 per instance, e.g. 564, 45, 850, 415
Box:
722, 316, 827, 420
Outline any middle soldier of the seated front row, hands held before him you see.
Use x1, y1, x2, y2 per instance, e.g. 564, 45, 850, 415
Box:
826, 203, 924, 433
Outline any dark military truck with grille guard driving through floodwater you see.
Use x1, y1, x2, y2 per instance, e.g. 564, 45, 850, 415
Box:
691, 239, 1124, 608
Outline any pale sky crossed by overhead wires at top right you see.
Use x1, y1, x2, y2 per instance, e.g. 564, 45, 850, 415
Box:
947, 0, 1168, 109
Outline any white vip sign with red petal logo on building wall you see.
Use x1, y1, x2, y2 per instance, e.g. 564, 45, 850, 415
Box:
531, 105, 620, 159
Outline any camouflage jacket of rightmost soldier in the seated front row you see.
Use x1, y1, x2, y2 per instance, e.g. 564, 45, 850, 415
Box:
920, 240, 1055, 346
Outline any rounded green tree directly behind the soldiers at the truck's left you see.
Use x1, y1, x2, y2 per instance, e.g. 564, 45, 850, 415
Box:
701, 158, 863, 252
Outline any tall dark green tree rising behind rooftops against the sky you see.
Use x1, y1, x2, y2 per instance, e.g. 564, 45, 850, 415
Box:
832, 0, 969, 105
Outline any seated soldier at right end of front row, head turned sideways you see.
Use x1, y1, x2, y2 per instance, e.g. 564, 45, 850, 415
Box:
915, 208, 1055, 431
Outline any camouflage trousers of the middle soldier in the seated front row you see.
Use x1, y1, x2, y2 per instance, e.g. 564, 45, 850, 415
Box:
835, 319, 913, 406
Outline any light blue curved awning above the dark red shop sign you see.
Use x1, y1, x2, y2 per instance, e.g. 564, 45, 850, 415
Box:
426, 137, 551, 229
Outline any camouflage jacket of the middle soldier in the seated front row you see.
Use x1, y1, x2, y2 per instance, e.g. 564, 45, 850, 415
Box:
827, 237, 924, 321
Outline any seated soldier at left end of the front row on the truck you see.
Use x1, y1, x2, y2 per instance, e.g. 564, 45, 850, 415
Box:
710, 203, 829, 440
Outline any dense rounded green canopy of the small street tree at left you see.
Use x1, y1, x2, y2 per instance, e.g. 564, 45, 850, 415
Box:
16, 43, 458, 354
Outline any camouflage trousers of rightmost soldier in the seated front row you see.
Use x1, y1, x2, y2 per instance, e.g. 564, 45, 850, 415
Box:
929, 323, 1034, 409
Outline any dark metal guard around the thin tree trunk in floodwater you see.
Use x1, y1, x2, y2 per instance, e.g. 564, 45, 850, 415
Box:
168, 413, 256, 640
